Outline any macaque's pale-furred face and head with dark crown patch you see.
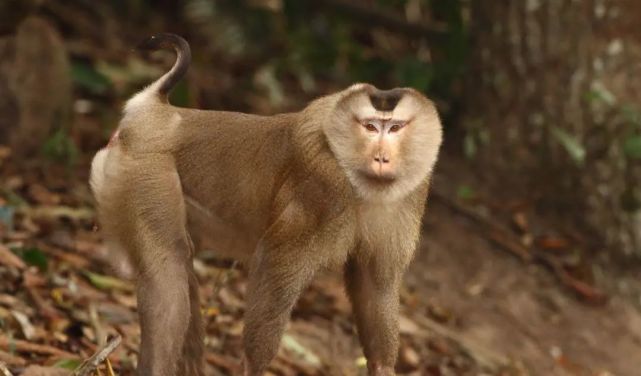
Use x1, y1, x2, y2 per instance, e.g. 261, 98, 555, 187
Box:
325, 84, 442, 200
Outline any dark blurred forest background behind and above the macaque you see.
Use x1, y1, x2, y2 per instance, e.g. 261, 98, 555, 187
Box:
0, 0, 641, 374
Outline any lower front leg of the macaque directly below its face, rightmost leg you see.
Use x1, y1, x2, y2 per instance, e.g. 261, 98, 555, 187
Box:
345, 258, 403, 376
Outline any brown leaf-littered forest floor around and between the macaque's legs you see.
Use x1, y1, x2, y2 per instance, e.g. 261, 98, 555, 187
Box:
0, 149, 641, 376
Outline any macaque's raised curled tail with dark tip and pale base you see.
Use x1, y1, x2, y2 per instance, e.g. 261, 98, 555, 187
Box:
125, 33, 191, 112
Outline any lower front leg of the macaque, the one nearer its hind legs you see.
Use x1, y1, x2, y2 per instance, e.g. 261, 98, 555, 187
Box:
243, 247, 315, 376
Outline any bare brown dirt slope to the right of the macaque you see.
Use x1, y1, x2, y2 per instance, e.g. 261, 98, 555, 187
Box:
408, 204, 641, 376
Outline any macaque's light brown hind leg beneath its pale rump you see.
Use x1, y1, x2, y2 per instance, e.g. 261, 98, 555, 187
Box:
115, 162, 203, 376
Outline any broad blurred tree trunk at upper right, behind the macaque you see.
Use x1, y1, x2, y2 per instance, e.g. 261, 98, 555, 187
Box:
465, 0, 641, 256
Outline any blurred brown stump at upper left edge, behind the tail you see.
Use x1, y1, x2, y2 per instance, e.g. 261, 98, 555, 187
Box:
0, 16, 71, 157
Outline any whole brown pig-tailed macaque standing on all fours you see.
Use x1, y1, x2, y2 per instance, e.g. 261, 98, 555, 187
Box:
91, 34, 442, 376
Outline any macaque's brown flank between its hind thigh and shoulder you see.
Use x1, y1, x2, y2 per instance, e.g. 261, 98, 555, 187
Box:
174, 110, 296, 256
